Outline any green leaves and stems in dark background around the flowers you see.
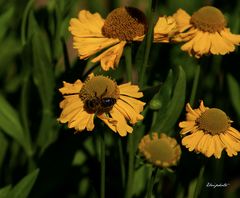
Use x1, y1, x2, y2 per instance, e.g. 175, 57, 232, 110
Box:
0, 0, 240, 198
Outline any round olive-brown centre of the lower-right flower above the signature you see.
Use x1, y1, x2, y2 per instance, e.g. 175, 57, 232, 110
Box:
197, 108, 230, 135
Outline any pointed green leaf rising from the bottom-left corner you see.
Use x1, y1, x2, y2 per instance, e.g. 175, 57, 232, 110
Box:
8, 169, 39, 198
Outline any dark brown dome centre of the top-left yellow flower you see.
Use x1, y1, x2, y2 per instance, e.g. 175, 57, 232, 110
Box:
102, 7, 147, 41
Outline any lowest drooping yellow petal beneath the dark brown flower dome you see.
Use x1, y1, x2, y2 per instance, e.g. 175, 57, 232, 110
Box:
92, 41, 126, 71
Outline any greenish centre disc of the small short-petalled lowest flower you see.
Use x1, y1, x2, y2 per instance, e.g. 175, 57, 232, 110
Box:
146, 139, 174, 162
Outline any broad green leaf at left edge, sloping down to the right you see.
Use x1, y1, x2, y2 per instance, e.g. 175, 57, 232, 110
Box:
0, 95, 32, 156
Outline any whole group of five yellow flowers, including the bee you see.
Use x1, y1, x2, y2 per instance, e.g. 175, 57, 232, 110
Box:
59, 6, 240, 167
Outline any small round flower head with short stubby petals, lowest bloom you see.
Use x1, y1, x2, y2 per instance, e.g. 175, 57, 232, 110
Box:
138, 132, 181, 168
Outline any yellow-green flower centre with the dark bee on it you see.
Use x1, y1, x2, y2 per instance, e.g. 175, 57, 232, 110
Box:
79, 76, 120, 114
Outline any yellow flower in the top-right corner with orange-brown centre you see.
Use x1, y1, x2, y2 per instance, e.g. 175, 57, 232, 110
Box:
173, 6, 240, 58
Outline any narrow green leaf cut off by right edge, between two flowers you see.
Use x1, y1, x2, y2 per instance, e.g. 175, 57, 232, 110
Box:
227, 74, 240, 118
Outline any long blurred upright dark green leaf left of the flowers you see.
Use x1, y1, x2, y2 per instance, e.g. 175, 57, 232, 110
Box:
33, 31, 57, 152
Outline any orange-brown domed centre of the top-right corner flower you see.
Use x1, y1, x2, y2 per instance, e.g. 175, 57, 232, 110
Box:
190, 6, 226, 33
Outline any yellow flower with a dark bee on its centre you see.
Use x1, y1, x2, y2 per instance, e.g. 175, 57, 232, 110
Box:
59, 74, 145, 136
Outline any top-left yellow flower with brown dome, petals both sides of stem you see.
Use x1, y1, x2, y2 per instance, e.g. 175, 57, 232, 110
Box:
69, 7, 176, 71
